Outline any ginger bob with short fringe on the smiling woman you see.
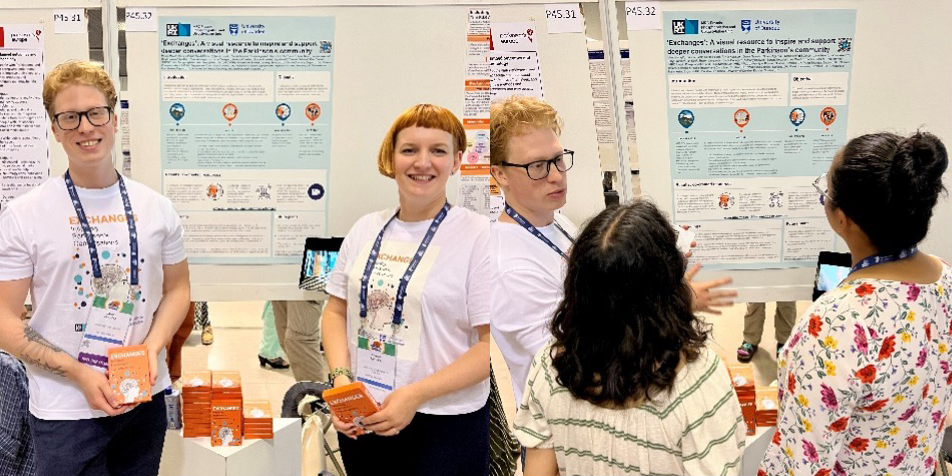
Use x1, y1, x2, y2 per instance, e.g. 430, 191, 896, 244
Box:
377, 104, 466, 178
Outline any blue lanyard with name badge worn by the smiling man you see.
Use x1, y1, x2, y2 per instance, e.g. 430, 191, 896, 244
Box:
65, 171, 139, 371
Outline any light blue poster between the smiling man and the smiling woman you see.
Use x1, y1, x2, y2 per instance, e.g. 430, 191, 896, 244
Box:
159, 17, 334, 264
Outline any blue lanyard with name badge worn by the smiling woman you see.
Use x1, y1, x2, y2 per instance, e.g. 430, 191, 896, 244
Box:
355, 202, 450, 402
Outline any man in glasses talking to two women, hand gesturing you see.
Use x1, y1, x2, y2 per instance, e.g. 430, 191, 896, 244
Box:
489, 96, 736, 401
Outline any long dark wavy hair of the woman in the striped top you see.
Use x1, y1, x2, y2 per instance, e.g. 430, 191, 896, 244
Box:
551, 200, 708, 406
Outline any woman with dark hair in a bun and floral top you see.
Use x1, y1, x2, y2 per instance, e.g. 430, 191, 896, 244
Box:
758, 132, 952, 476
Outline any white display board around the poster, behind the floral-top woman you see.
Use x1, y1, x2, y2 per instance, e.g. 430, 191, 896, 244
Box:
628, 0, 952, 301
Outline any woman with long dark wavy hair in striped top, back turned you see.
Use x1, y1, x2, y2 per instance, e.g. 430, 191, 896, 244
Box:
515, 201, 745, 476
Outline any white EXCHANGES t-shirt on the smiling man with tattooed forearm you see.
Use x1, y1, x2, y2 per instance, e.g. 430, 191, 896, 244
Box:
0, 177, 185, 420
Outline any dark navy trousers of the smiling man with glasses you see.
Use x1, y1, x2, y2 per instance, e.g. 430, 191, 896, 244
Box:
30, 393, 166, 476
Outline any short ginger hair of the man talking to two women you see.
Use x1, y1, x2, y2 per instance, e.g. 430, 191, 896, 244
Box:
489, 96, 562, 165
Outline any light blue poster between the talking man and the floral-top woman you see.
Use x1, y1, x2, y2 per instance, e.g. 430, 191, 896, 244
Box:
664, 10, 856, 269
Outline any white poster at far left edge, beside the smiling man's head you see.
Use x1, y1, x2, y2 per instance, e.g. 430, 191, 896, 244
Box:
0, 24, 50, 208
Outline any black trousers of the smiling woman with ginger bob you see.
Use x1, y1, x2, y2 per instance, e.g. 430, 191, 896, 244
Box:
338, 404, 489, 476
